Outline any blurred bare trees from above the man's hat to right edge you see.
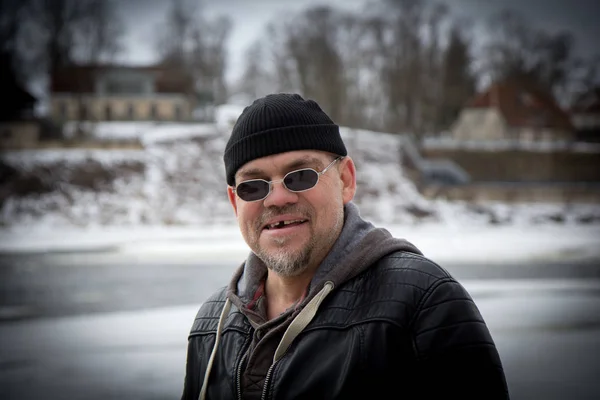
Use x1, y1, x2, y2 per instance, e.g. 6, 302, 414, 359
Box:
237, 0, 600, 135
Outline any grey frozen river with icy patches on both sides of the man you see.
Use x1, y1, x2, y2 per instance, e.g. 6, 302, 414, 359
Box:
0, 256, 600, 400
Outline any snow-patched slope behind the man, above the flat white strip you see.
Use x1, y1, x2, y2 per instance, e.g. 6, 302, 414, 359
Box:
0, 119, 600, 227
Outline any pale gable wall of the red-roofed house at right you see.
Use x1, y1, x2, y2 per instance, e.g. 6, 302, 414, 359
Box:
451, 108, 509, 140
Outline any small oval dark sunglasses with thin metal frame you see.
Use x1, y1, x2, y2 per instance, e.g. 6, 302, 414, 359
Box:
233, 157, 344, 202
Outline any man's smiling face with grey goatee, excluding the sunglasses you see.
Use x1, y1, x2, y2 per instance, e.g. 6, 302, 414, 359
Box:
228, 150, 356, 277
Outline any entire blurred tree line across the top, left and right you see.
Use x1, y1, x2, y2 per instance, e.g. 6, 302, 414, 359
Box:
0, 0, 600, 135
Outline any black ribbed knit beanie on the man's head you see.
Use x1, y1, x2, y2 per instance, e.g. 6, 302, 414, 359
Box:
223, 93, 348, 186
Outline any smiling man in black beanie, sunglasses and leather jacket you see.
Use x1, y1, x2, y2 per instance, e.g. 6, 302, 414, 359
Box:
182, 94, 509, 400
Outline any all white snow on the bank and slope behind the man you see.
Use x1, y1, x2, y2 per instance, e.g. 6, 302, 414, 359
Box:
0, 104, 600, 262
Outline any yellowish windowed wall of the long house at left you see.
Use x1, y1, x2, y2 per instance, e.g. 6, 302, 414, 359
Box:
51, 94, 192, 121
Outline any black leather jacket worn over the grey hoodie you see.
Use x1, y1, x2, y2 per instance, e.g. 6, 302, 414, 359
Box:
182, 251, 509, 400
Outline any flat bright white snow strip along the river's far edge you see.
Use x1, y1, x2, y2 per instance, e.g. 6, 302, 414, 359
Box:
0, 223, 600, 264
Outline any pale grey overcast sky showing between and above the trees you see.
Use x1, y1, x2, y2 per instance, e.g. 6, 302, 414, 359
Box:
117, 0, 600, 83
